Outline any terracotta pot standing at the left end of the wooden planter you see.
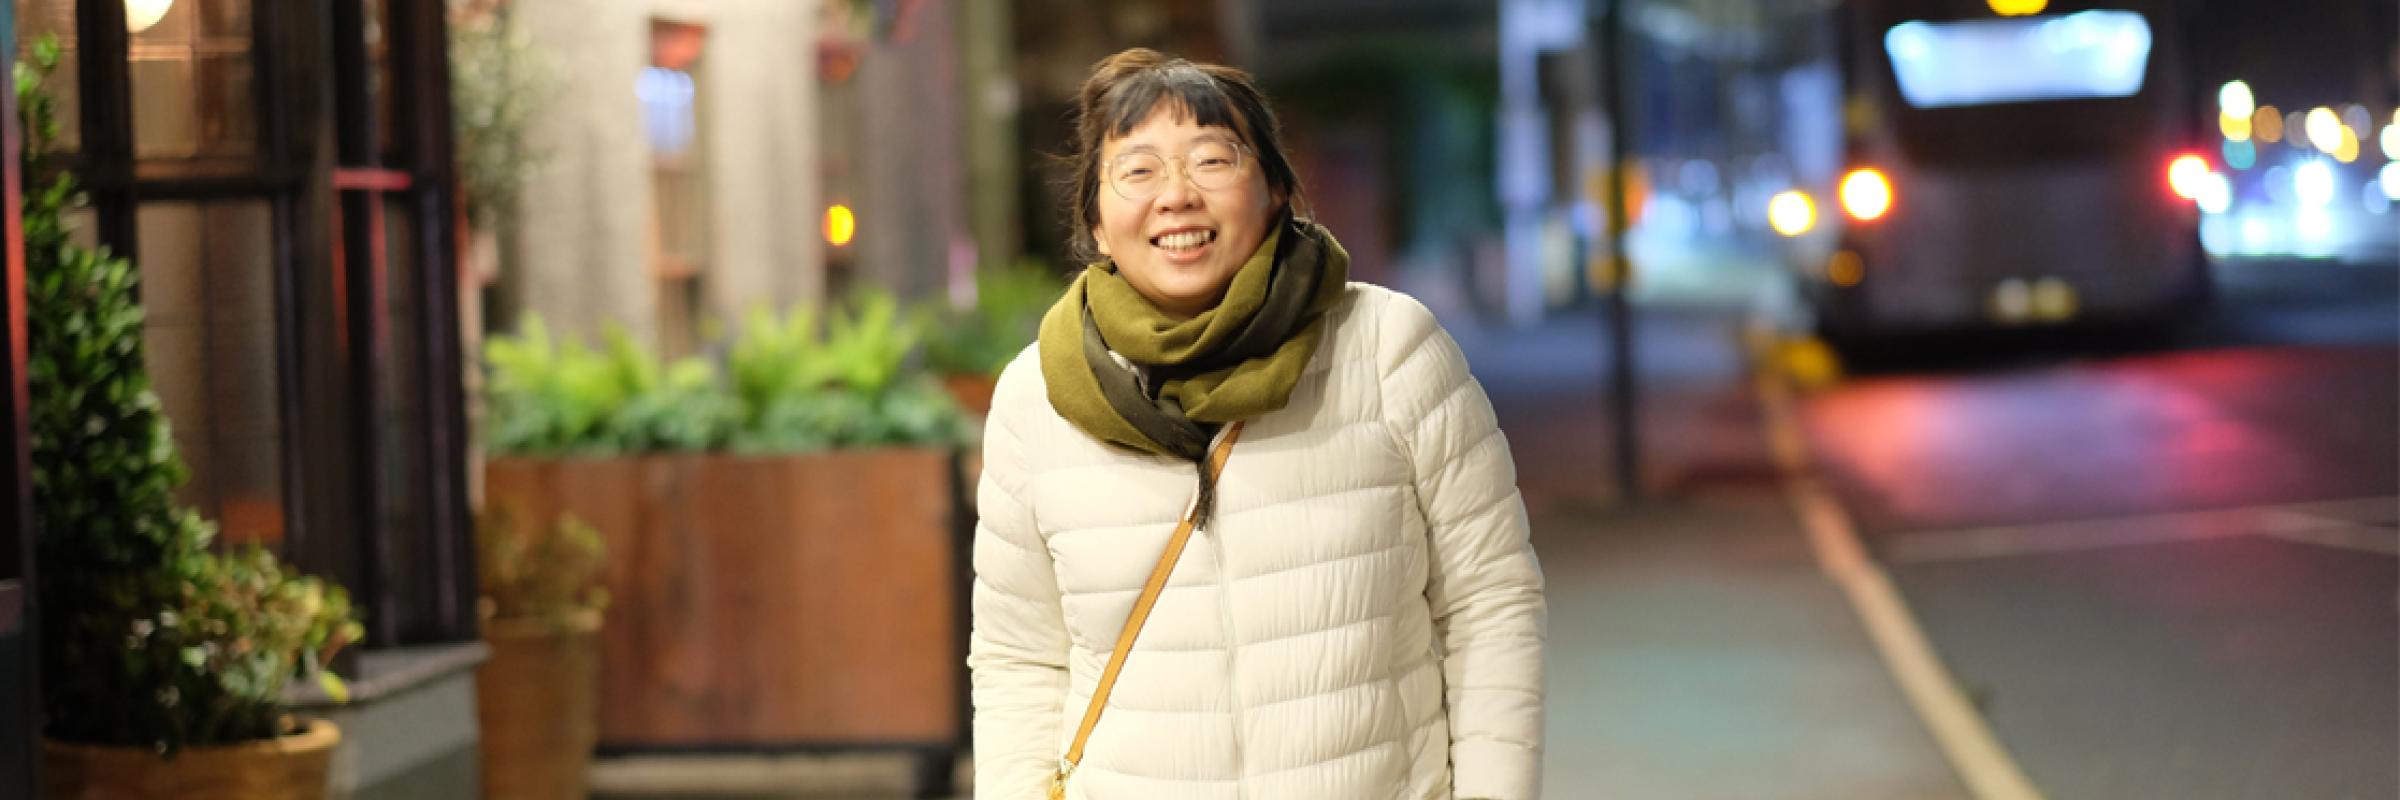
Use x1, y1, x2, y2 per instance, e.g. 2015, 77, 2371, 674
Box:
475, 610, 600, 800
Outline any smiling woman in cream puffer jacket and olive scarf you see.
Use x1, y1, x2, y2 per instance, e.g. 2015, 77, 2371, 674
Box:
967, 50, 1543, 800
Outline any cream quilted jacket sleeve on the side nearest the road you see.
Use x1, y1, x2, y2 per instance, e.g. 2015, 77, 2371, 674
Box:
1378, 293, 1548, 800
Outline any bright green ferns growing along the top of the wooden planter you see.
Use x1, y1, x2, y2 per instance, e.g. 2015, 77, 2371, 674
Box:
485, 291, 970, 456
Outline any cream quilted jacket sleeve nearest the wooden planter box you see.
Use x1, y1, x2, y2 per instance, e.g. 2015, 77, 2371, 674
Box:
967, 353, 1068, 800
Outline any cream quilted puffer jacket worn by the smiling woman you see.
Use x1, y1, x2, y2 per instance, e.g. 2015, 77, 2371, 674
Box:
967, 283, 1546, 800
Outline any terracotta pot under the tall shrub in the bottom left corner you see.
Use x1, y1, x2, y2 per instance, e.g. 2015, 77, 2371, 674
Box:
41, 721, 341, 800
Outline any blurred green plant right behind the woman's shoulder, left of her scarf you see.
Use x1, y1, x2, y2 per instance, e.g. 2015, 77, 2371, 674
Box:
924, 262, 1066, 375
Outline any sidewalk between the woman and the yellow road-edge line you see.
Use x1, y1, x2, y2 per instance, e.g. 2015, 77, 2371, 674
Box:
1459, 308, 1970, 800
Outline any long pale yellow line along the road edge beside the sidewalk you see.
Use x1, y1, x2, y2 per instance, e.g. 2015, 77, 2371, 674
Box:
1754, 370, 2042, 800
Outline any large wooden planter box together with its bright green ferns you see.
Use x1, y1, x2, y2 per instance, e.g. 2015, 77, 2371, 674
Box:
485, 293, 967, 762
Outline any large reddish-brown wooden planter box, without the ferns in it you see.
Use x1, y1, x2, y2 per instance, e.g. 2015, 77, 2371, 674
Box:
487, 449, 965, 752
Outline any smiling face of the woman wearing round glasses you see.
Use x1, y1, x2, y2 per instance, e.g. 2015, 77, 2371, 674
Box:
1092, 103, 1279, 320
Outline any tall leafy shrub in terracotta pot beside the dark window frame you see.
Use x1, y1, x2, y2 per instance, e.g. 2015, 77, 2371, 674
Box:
14, 38, 362, 800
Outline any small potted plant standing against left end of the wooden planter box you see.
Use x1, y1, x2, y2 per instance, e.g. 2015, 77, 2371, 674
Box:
475, 505, 607, 800
